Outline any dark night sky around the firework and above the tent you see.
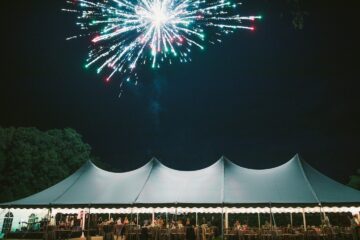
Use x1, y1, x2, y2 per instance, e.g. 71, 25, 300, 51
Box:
0, 0, 360, 182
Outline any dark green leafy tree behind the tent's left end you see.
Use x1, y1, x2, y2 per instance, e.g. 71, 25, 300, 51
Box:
0, 127, 91, 202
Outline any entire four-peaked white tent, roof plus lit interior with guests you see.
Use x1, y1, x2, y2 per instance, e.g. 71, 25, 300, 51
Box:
0, 155, 360, 240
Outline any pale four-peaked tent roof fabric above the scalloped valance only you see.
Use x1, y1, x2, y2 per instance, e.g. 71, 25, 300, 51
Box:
2, 155, 360, 207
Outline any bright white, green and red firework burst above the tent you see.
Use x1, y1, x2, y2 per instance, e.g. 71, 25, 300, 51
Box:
63, 0, 261, 83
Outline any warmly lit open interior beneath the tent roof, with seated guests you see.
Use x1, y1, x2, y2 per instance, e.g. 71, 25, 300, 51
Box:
2, 211, 360, 240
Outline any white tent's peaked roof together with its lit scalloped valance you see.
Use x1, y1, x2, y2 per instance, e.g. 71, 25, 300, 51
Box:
0, 155, 360, 234
